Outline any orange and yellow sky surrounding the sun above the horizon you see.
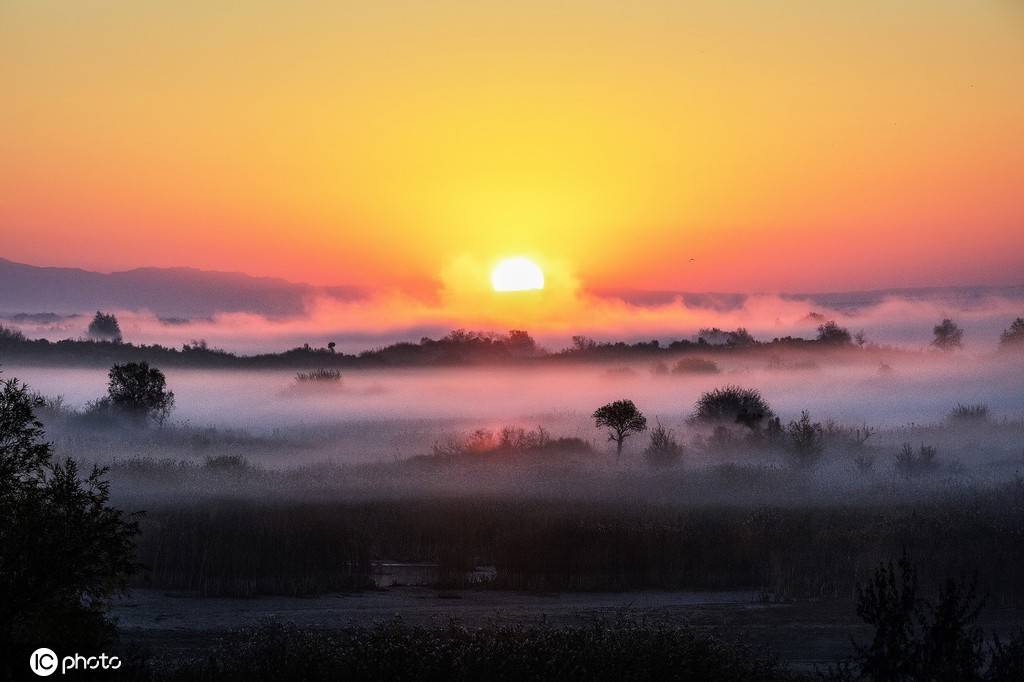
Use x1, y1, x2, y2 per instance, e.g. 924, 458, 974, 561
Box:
0, 0, 1024, 299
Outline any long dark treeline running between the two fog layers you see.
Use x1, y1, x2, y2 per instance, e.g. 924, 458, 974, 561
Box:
0, 323, 929, 369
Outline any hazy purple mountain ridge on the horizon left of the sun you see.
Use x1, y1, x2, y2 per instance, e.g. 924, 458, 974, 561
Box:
0, 258, 364, 317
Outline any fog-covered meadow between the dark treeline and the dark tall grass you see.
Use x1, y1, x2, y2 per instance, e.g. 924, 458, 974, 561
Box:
5, 352, 1024, 504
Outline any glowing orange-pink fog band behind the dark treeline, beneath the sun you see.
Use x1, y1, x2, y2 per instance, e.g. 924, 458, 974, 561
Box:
6, 287, 1024, 354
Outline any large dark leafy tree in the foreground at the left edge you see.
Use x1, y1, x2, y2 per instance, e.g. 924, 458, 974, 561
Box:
0, 379, 138, 667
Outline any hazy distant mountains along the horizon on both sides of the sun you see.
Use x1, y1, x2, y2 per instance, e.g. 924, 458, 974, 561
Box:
0, 258, 1024, 323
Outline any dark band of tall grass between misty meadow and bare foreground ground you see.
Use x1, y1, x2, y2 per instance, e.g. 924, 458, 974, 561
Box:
132, 481, 1024, 604
